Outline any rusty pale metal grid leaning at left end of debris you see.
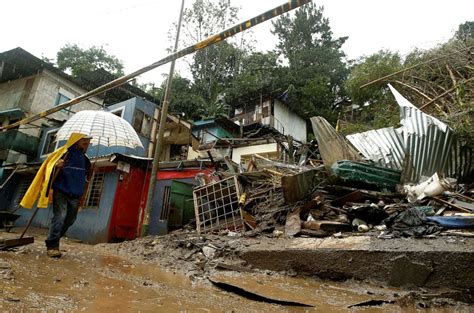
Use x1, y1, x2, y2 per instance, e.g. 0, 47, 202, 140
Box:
193, 176, 244, 234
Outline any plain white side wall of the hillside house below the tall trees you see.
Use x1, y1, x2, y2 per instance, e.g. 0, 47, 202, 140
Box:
273, 100, 306, 142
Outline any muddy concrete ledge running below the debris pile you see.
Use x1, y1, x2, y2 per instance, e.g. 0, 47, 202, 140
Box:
240, 236, 474, 289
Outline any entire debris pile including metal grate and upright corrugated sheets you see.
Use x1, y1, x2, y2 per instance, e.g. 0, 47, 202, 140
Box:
194, 88, 474, 238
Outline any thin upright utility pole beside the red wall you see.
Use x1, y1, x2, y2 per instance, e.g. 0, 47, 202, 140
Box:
141, 0, 184, 237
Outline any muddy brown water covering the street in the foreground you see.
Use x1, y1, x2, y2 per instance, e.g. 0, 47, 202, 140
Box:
0, 232, 466, 312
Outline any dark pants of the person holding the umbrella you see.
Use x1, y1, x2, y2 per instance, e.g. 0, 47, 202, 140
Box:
45, 190, 79, 248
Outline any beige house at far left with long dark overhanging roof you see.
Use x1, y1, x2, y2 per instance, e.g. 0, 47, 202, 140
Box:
0, 48, 152, 171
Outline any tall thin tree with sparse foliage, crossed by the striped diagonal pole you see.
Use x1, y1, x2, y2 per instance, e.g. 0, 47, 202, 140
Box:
170, 0, 252, 116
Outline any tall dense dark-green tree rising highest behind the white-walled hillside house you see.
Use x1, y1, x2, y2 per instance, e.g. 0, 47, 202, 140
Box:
272, 3, 348, 121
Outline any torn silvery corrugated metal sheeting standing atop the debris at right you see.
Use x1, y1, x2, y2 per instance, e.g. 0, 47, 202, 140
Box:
347, 85, 474, 182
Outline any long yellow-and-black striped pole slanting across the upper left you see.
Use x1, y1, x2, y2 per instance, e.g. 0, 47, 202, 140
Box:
0, 0, 311, 130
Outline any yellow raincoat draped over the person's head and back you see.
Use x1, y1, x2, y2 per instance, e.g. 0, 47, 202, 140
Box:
20, 133, 86, 209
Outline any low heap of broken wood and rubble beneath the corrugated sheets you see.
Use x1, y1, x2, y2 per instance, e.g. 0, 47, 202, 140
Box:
194, 155, 474, 238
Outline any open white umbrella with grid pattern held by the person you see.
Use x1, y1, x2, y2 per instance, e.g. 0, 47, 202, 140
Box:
56, 110, 143, 149
